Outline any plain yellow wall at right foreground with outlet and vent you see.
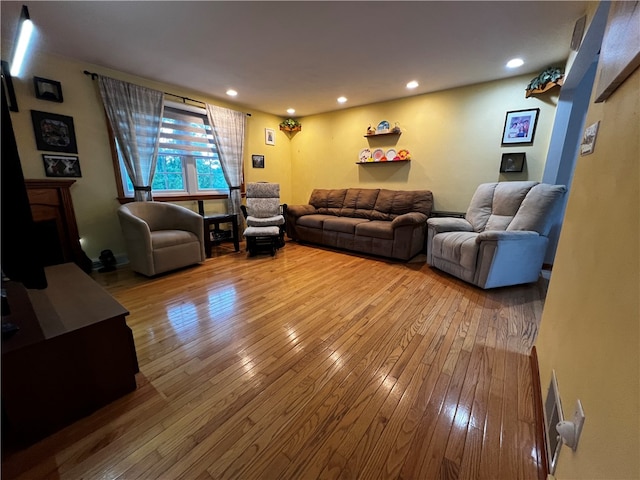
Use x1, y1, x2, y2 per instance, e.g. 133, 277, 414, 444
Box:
537, 65, 640, 480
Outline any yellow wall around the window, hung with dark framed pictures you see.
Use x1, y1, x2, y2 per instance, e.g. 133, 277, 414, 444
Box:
2, 50, 291, 259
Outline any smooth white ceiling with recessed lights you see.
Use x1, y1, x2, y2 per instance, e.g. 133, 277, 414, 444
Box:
1, 0, 587, 117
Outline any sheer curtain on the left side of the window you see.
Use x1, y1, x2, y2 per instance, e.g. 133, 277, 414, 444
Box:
98, 76, 164, 202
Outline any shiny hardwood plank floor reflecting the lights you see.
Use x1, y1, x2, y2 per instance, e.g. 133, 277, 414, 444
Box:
2, 242, 546, 480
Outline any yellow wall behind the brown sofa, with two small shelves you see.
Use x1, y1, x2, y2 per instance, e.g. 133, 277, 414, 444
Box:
291, 74, 557, 211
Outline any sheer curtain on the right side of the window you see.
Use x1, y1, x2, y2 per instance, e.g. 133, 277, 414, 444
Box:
207, 105, 247, 223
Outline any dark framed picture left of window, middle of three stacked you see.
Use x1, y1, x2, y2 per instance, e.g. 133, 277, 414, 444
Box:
31, 110, 78, 153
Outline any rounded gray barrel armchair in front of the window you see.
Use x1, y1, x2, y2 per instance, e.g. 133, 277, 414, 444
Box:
118, 202, 205, 277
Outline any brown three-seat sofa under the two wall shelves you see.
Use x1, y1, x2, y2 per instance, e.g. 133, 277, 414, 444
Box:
286, 188, 433, 260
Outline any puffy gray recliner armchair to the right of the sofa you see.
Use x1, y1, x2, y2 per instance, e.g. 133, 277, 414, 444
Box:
427, 182, 566, 289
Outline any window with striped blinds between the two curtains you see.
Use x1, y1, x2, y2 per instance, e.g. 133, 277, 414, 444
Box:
116, 102, 228, 197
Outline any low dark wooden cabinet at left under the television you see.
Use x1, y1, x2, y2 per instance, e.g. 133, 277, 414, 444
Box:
2, 263, 138, 445
